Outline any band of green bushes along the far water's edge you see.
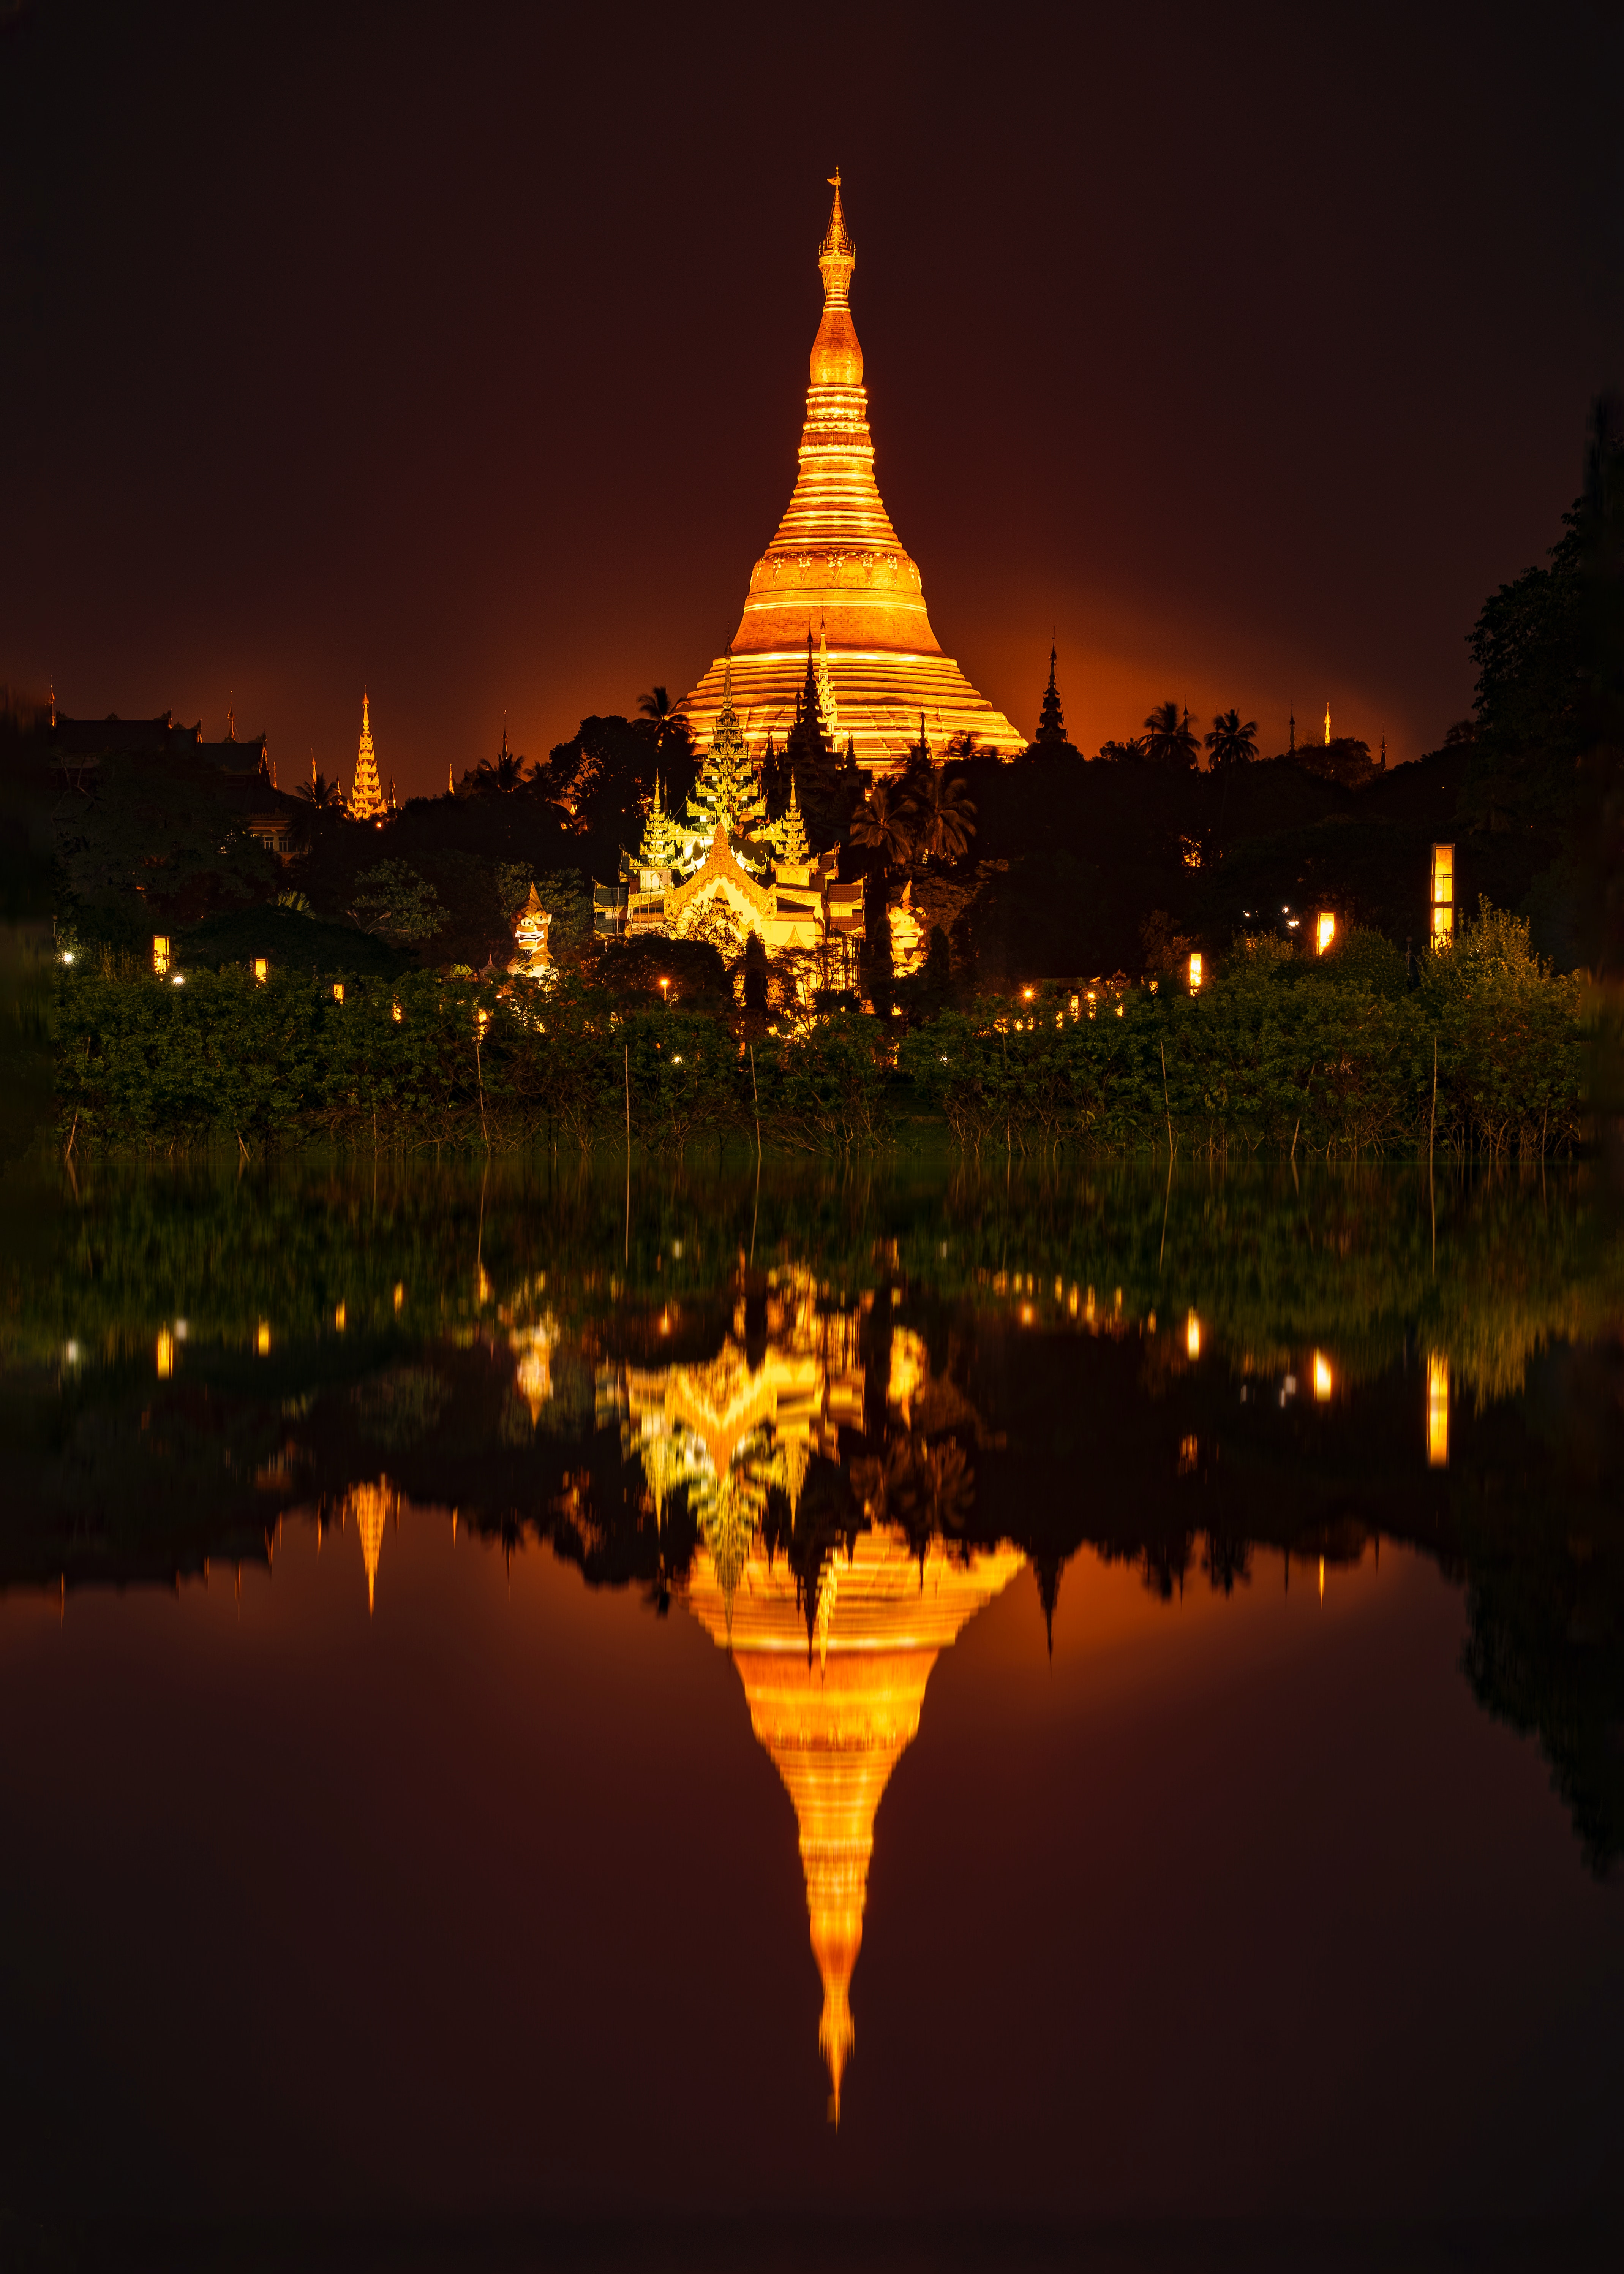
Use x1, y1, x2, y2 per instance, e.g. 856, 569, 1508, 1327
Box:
55, 907, 1588, 1160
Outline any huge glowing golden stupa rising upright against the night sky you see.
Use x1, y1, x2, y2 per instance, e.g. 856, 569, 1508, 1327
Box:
680, 168, 1026, 771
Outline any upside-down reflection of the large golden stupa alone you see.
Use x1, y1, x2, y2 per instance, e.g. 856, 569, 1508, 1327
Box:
687, 1531, 1024, 2122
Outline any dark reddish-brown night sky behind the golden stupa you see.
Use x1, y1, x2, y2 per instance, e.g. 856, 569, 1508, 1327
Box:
0, 0, 1624, 796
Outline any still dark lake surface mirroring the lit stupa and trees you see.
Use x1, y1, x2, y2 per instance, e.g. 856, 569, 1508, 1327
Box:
0, 1164, 1624, 2265
